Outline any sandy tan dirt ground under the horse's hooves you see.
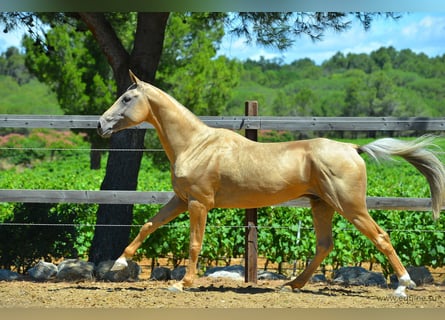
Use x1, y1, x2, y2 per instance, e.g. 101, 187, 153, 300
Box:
0, 272, 445, 309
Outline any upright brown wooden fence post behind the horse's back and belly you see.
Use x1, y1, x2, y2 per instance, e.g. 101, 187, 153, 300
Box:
244, 101, 258, 283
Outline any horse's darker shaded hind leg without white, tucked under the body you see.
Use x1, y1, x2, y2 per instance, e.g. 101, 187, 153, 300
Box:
285, 199, 334, 289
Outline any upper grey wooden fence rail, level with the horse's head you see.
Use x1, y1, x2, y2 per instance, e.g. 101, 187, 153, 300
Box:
0, 114, 445, 131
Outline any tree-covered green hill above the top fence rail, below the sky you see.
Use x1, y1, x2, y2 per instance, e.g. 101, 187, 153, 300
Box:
0, 47, 445, 122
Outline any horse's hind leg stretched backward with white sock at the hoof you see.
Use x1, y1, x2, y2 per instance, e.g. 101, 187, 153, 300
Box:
342, 205, 416, 297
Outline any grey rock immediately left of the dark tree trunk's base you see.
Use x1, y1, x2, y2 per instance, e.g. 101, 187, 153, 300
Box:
56, 259, 94, 281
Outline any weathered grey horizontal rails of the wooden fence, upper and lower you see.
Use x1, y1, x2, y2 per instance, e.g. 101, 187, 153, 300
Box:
0, 114, 445, 211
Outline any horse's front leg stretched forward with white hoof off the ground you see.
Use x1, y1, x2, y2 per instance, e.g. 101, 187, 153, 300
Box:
111, 195, 187, 271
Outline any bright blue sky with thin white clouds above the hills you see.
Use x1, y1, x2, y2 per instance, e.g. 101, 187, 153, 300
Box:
0, 12, 445, 64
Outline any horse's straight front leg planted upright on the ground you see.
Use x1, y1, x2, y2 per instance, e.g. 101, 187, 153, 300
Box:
171, 200, 208, 291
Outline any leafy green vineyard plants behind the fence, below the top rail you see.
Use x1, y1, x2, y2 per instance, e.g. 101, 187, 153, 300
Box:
0, 130, 445, 274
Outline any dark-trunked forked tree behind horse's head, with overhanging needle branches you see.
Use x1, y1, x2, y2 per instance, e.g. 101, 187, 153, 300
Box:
0, 12, 395, 262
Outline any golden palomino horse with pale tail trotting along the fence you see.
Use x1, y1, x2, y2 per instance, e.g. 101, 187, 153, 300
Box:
98, 71, 445, 296
